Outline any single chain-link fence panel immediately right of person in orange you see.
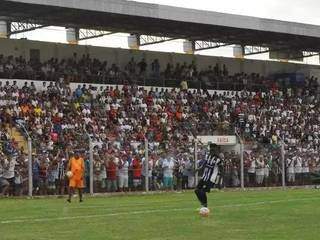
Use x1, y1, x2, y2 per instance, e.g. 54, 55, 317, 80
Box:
90, 141, 147, 193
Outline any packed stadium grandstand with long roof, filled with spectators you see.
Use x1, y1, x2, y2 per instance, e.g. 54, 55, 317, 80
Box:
0, 0, 320, 195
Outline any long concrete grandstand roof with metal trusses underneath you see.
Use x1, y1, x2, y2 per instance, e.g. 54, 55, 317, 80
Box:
0, 0, 320, 59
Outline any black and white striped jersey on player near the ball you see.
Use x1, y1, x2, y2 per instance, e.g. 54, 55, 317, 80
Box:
202, 154, 222, 183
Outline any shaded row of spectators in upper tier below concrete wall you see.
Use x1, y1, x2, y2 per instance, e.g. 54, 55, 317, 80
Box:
0, 53, 319, 91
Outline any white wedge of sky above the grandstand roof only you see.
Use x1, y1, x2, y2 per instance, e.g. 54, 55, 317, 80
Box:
132, 0, 320, 25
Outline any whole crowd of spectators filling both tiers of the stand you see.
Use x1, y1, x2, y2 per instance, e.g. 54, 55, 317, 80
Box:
0, 52, 320, 194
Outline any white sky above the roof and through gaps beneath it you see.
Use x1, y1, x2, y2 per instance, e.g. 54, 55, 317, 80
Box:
10, 0, 320, 63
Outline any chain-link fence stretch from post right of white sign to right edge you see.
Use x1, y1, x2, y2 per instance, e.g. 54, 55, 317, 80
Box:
244, 137, 320, 187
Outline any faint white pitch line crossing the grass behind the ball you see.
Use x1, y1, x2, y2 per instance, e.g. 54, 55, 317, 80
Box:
0, 197, 319, 224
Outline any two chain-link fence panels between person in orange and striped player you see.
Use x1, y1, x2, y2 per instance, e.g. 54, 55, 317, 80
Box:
86, 141, 195, 193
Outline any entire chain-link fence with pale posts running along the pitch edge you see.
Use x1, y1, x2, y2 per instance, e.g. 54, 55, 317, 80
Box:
0, 127, 320, 196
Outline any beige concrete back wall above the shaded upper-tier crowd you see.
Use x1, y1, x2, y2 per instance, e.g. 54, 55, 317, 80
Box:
0, 39, 320, 76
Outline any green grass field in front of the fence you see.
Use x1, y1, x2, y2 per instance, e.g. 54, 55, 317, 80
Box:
0, 190, 320, 240
